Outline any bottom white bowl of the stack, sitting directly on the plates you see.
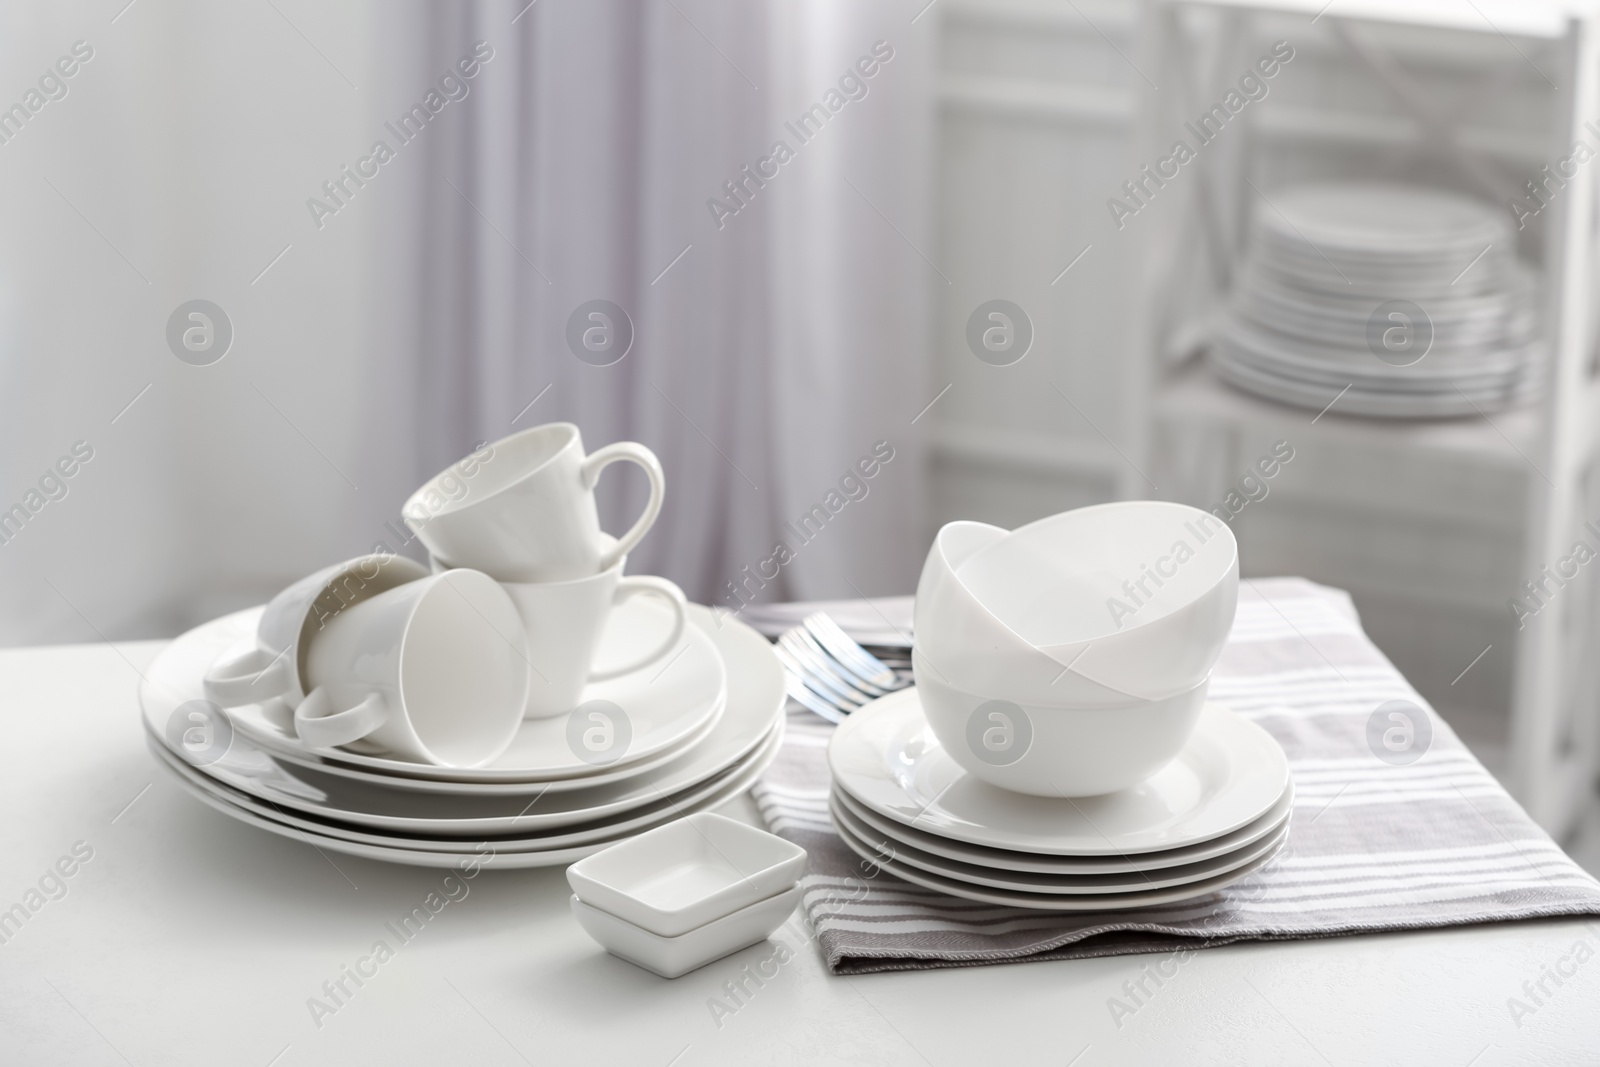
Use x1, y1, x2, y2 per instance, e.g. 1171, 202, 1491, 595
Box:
912, 649, 1211, 797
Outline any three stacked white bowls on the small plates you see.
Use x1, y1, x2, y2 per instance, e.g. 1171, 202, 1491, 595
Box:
912, 501, 1238, 797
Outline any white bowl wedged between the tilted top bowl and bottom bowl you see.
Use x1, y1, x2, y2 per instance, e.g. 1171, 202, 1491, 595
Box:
912, 522, 1136, 705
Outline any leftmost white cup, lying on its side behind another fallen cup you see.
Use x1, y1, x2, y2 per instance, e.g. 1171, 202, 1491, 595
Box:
203, 553, 427, 707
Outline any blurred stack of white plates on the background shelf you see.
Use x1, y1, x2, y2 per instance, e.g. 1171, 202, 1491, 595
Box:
1213, 182, 1541, 418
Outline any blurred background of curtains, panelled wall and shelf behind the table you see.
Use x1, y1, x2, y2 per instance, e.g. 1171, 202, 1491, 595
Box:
0, 0, 1600, 849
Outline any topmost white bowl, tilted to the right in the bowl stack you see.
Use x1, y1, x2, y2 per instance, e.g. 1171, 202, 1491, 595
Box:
933, 501, 1238, 702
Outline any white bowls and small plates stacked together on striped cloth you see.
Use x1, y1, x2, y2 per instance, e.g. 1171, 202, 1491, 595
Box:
829, 501, 1293, 910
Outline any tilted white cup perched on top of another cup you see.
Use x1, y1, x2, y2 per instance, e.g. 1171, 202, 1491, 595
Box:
402, 422, 664, 582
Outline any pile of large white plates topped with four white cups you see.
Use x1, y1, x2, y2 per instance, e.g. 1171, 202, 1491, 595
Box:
141, 424, 784, 876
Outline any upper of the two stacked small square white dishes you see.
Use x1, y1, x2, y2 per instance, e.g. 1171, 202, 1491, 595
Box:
566, 811, 805, 937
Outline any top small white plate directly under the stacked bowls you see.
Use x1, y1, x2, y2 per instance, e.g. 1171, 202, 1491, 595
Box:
827, 688, 1290, 856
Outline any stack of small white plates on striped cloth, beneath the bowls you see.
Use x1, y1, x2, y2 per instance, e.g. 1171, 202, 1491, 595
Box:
827, 689, 1294, 912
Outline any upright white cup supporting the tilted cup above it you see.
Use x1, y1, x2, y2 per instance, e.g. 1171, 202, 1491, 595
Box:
434, 550, 688, 718
